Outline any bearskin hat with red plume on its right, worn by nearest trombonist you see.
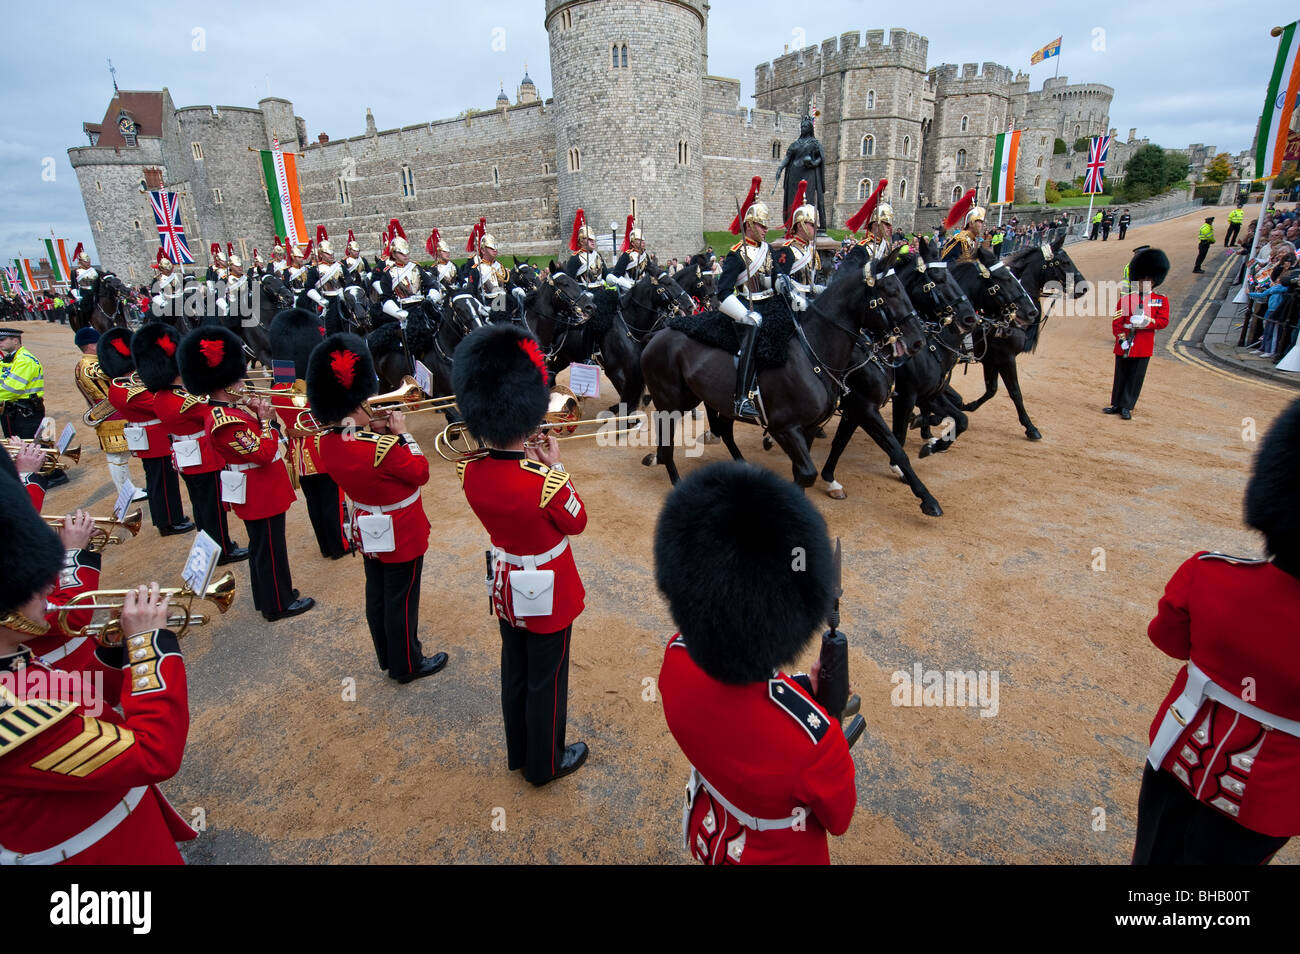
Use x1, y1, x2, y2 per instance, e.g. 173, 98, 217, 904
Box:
451, 325, 550, 447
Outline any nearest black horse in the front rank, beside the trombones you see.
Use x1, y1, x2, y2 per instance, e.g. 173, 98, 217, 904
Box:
641, 248, 923, 487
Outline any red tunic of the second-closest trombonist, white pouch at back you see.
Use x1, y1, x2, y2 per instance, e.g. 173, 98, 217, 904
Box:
308, 428, 429, 563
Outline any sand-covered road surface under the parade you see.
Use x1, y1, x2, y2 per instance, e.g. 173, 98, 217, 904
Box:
26, 207, 1300, 863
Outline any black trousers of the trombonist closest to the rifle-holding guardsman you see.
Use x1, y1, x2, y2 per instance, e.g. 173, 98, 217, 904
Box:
497, 617, 573, 785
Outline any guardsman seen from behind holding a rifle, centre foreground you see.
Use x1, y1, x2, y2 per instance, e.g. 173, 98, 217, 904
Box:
654, 461, 857, 864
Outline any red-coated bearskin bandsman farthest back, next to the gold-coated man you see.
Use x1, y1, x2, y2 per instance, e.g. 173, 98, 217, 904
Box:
96, 328, 194, 537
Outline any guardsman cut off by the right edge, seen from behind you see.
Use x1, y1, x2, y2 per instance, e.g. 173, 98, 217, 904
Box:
1134, 400, 1300, 864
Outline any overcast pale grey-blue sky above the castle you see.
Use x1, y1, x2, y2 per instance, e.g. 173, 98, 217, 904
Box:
0, 0, 1294, 265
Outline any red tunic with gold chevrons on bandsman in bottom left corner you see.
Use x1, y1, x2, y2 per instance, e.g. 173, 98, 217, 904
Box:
0, 630, 196, 864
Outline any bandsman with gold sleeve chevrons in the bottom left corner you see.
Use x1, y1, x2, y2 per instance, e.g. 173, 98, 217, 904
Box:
0, 476, 195, 866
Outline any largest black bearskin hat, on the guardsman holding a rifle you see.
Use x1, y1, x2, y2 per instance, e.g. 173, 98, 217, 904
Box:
654, 461, 833, 684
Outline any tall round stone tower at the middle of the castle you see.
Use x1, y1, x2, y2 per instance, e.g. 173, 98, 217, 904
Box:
546, 0, 709, 259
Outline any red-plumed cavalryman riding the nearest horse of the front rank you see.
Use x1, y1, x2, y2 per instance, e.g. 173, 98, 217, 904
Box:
718, 175, 775, 421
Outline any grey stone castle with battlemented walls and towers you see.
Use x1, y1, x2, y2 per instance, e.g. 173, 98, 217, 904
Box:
68, 0, 1145, 282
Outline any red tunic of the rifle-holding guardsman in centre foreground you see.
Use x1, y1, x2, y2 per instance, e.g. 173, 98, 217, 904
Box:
659, 636, 858, 864
